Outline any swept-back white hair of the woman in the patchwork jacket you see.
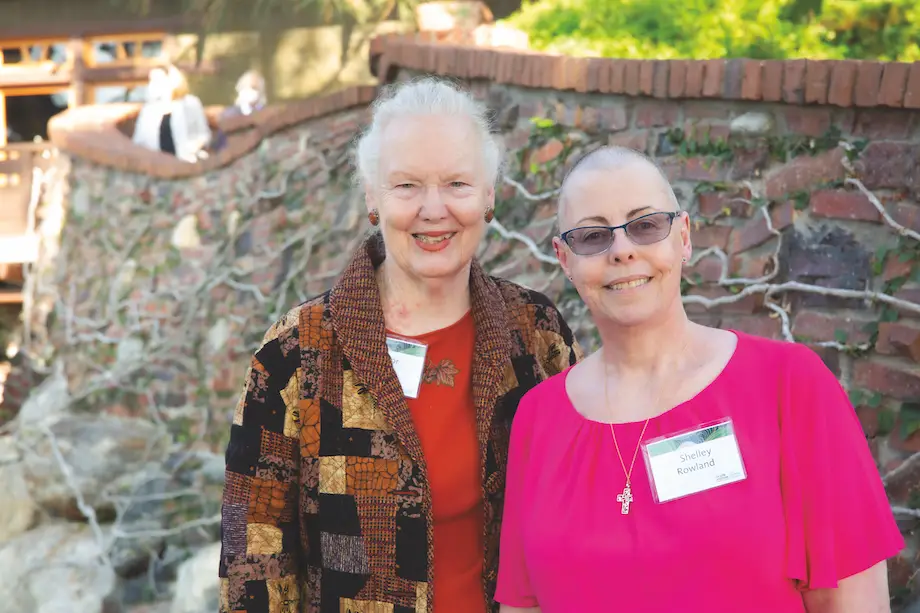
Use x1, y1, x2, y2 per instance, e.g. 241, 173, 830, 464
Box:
354, 77, 503, 187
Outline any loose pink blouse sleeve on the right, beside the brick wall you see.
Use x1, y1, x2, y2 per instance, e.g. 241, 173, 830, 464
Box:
780, 345, 904, 589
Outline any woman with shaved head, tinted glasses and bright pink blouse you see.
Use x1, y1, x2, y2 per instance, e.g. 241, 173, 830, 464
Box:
496, 148, 904, 613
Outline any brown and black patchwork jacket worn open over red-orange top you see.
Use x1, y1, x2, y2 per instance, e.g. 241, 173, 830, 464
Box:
220, 236, 581, 613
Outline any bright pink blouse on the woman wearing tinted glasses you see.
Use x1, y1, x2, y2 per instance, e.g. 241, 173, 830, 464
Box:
495, 332, 904, 613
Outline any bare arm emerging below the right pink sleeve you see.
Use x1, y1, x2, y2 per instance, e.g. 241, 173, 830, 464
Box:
800, 561, 891, 613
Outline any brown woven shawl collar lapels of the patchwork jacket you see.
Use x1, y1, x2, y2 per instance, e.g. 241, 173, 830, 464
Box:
329, 234, 511, 479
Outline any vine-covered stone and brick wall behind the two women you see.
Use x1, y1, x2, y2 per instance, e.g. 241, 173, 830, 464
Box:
10, 32, 920, 607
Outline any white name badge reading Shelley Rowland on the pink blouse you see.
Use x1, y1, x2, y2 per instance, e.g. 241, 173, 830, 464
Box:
642, 419, 747, 503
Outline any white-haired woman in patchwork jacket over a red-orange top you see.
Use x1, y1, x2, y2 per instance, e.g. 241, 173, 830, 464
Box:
220, 80, 580, 613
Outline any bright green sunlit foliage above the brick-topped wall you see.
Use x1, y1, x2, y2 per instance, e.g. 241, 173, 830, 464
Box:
506, 0, 920, 62
